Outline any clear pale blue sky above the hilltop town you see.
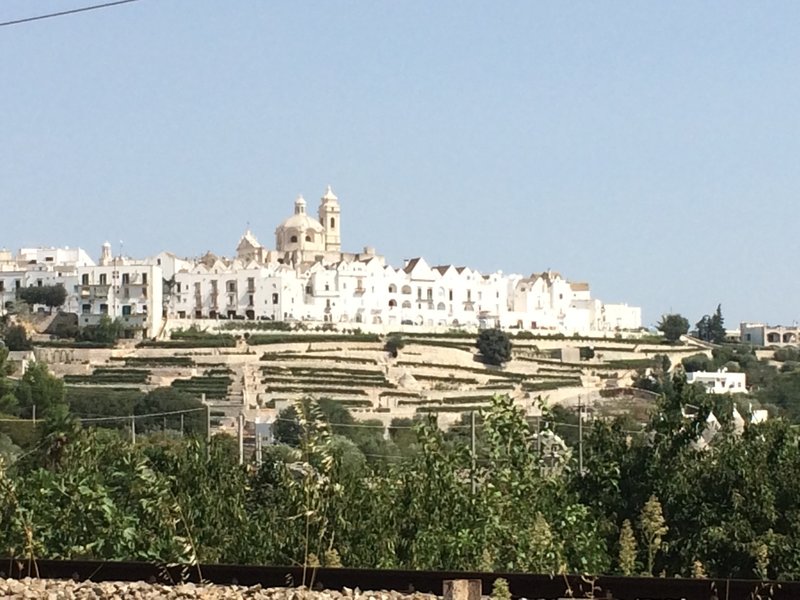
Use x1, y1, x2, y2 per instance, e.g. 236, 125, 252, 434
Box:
0, 0, 800, 326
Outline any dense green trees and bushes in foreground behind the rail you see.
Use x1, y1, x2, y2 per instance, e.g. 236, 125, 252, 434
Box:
0, 342, 800, 578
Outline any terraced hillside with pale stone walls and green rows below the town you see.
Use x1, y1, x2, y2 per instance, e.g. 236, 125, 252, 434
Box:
36, 332, 705, 428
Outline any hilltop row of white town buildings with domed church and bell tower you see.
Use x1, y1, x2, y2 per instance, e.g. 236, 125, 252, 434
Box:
0, 187, 641, 337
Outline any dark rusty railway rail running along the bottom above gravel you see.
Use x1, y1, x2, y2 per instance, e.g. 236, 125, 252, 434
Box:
0, 559, 800, 600
